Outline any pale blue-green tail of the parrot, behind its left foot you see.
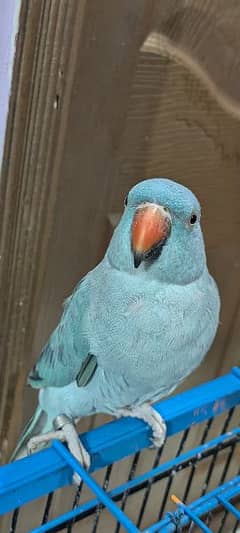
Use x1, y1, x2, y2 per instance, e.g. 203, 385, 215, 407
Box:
10, 406, 51, 462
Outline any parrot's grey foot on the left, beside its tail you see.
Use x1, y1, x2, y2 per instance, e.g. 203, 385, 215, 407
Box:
27, 415, 90, 485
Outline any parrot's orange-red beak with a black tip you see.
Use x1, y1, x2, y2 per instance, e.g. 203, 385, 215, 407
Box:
132, 203, 171, 268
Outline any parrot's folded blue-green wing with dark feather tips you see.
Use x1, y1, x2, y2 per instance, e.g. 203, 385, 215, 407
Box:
28, 276, 97, 388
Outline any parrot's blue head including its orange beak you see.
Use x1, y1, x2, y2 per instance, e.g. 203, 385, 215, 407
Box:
107, 178, 206, 284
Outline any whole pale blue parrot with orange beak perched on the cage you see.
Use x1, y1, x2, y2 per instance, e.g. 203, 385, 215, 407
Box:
13, 178, 220, 476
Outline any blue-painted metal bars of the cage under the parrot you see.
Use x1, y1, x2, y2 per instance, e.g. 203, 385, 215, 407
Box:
0, 368, 240, 533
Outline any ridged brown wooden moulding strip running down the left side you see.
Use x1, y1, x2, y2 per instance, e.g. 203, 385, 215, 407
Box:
0, 0, 86, 457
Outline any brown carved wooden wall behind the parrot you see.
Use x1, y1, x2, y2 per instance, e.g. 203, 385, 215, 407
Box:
0, 0, 240, 524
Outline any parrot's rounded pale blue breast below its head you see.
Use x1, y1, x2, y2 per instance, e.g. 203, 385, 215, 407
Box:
91, 264, 220, 402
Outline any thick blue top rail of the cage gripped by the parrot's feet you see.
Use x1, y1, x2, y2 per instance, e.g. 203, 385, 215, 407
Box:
0, 368, 240, 514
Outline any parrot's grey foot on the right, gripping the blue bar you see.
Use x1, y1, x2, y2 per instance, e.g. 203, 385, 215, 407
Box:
118, 403, 167, 448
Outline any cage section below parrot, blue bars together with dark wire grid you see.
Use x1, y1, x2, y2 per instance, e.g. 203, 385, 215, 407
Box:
0, 367, 240, 533
